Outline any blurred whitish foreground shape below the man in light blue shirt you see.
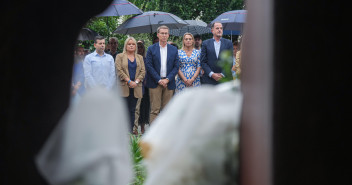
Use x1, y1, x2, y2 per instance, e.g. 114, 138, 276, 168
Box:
36, 87, 133, 185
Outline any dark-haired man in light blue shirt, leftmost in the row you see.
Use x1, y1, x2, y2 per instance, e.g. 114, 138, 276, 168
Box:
83, 36, 116, 90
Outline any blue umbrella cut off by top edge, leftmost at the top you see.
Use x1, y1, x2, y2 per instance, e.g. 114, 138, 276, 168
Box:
96, 0, 143, 17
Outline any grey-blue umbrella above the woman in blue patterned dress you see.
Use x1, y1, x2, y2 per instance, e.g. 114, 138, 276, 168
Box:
170, 20, 211, 36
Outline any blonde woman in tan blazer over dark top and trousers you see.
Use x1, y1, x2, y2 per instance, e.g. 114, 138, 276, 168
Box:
115, 37, 145, 133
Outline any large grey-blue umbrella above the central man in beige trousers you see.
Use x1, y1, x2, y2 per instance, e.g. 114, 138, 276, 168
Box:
114, 11, 188, 34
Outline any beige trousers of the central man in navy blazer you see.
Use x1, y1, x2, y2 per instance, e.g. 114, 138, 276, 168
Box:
149, 85, 174, 124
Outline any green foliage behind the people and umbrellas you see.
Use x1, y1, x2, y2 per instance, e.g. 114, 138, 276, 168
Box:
82, 0, 244, 49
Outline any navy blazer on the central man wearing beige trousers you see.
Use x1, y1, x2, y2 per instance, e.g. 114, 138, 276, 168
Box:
146, 42, 178, 90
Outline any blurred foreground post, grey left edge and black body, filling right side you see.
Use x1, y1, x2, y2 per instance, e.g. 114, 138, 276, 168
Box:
240, 0, 352, 185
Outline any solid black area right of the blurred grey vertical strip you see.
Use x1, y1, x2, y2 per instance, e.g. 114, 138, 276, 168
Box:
273, 0, 352, 185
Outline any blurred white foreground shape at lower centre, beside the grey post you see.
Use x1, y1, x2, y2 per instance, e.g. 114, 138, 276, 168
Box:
140, 81, 242, 185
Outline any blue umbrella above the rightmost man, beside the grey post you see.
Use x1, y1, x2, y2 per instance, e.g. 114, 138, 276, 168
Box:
208, 10, 247, 32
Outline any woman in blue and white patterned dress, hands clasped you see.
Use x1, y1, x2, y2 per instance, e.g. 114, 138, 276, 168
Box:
175, 33, 201, 93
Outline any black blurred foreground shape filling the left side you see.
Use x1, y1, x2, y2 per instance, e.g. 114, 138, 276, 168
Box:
0, 0, 111, 185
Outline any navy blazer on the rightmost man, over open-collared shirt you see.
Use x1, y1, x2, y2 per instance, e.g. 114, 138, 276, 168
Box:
200, 38, 233, 85
